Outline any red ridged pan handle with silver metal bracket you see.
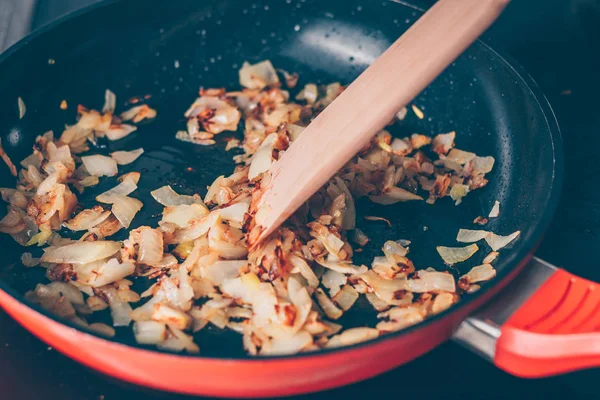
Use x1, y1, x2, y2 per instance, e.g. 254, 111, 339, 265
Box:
455, 259, 600, 378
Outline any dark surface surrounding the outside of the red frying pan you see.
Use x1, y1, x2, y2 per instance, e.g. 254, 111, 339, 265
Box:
0, 0, 600, 400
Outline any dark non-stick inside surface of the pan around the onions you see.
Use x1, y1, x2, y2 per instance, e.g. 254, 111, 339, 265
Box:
0, 0, 560, 356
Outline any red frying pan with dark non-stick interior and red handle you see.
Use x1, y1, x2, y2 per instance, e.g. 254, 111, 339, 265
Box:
0, 0, 600, 397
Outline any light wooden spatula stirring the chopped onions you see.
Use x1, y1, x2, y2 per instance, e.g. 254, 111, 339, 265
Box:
251, 0, 509, 241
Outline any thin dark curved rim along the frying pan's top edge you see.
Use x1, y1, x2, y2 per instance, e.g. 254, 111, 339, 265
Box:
0, 0, 564, 363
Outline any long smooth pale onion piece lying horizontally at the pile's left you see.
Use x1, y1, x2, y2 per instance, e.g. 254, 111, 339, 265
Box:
41, 240, 121, 264
